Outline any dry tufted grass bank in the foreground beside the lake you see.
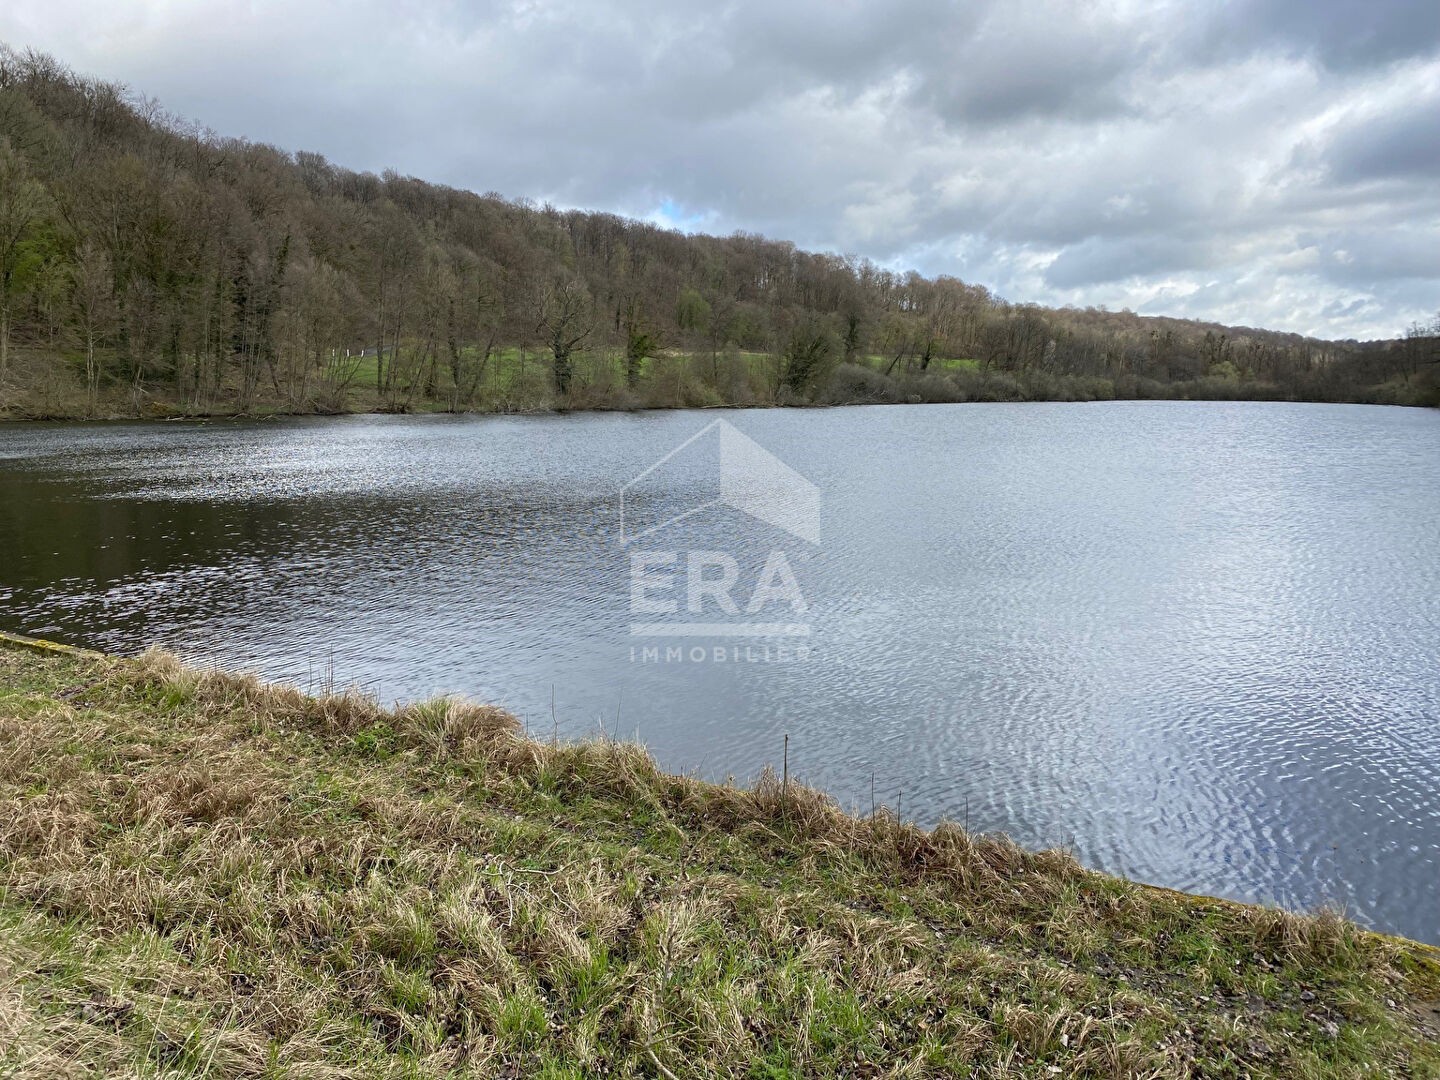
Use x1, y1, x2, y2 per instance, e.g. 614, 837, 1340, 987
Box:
0, 647, 1440, 1077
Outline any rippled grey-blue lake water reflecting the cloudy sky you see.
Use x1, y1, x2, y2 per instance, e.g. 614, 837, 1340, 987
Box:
0, 403, 1440, 942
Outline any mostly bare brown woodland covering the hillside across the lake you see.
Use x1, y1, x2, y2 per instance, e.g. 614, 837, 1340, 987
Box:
0, 46, 1440, 418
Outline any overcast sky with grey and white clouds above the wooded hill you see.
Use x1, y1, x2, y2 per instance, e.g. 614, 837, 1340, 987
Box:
0, 0, 1440, 338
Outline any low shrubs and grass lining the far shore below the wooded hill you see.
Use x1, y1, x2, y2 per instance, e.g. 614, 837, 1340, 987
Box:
8, 347, 1440, 420
